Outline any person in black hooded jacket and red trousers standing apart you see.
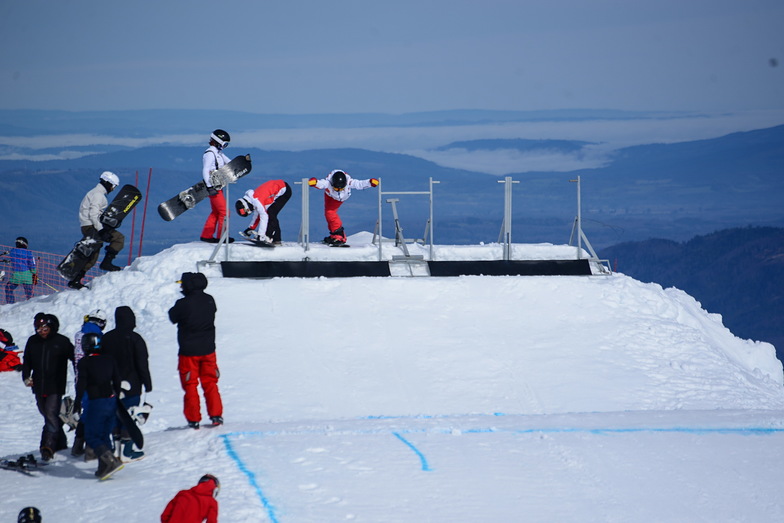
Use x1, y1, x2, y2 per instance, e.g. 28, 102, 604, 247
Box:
169, 272, 223, 429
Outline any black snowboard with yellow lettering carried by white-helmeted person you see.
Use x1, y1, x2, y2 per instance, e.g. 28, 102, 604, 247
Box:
57, 184, 142, 281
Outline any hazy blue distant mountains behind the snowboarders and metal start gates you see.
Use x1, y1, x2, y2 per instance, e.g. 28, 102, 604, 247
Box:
0, 111, 784, 258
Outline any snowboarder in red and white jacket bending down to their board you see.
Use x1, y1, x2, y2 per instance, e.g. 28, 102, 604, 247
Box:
234, 180, 291, 245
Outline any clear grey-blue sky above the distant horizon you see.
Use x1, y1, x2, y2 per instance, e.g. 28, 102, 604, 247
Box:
0, 0, 784, 113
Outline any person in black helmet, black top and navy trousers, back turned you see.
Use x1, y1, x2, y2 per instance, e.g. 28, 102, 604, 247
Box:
74, 332, 123, 479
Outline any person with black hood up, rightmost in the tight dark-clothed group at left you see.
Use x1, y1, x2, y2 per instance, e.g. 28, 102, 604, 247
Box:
102, 305, 152, 461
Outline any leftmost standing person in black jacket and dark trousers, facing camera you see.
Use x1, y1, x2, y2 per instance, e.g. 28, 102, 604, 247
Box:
22, 313, 74, 461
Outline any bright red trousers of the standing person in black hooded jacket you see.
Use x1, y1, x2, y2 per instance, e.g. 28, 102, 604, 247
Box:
177, 352, 223, 421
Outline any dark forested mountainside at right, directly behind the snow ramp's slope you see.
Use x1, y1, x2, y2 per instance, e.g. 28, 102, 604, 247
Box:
599, 227, 784, 361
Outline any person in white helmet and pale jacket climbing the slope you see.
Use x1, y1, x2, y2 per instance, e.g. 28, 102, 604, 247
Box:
68, 171, 125, 289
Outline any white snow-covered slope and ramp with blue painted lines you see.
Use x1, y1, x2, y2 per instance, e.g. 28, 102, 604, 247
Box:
0, 237, 784, 522
